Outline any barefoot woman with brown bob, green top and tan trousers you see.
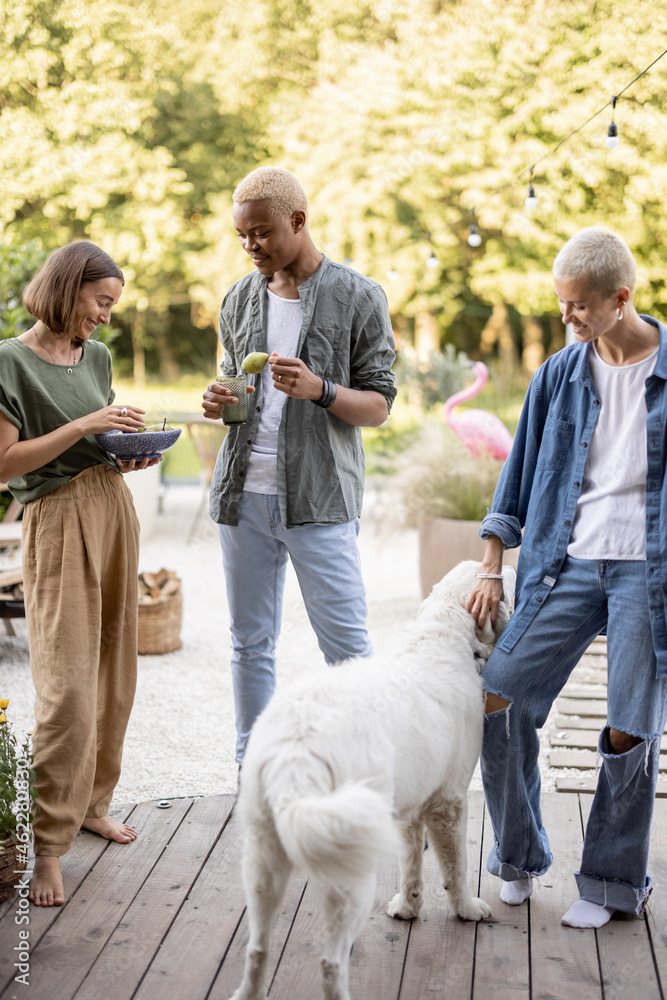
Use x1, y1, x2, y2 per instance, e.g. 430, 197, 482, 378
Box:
0, 241, 159, 906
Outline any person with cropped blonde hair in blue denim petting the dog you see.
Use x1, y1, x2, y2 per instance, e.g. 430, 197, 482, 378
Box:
469, 227, 667, 927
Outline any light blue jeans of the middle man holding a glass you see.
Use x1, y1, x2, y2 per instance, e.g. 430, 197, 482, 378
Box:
218, 492, 373, 763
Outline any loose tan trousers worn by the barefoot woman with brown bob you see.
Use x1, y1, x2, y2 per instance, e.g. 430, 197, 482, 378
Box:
23, 465, 139, 856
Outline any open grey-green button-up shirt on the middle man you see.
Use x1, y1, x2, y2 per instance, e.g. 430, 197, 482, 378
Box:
210, 257, 396, 528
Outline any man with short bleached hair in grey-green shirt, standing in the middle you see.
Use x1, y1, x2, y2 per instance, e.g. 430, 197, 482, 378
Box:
203, 167, 395, 765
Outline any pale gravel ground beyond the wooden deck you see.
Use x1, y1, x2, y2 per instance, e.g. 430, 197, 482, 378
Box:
0, 476, 562, 802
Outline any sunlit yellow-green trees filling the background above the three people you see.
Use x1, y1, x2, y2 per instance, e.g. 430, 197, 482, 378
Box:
0, 0, 667, 385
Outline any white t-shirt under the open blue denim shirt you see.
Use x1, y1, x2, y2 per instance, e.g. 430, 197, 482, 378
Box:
567, 344, 658, 559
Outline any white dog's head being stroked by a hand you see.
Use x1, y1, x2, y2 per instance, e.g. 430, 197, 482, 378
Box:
419, 559, 516, 670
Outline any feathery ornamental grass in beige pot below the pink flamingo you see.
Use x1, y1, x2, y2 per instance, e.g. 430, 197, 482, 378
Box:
396, 420, 519, 597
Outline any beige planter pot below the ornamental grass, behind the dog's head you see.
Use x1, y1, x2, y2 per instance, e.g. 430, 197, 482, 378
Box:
418, 517, 519, 597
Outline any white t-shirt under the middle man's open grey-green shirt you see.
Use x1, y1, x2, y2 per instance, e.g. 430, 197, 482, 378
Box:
243, 288, 301, 493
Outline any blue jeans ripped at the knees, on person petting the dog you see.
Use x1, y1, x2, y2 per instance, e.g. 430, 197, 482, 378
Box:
481, 557, 667, 914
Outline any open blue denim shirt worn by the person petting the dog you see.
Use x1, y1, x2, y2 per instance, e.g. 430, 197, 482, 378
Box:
480, 316, 667, 677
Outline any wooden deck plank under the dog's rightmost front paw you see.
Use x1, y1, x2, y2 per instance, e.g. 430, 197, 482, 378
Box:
396, 792, 490, 1000
